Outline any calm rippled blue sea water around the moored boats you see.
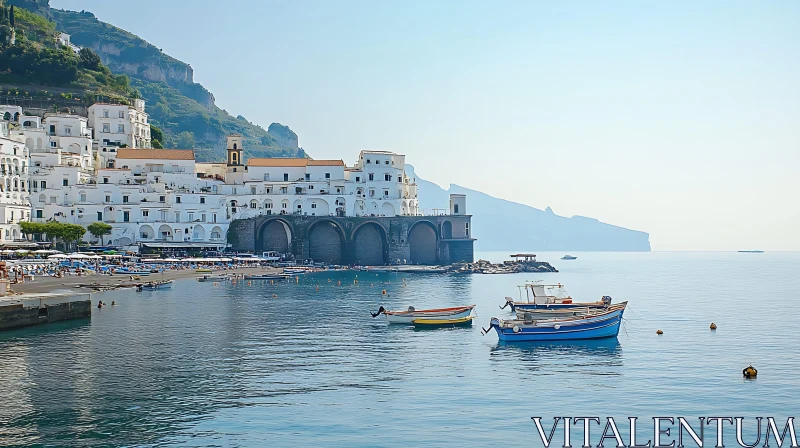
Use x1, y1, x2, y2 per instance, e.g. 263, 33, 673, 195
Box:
0, 253, 800, 446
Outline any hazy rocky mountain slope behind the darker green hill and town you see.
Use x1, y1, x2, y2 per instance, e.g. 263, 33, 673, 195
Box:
7, 0, 305, 161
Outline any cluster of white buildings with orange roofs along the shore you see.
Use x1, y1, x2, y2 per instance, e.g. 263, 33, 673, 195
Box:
0, 99, 420, 251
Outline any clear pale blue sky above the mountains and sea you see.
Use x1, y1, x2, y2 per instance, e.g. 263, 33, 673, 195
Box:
51, 0, 800, 251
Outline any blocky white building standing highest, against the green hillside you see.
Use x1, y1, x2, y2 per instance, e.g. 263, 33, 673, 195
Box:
89, 99, 152, 148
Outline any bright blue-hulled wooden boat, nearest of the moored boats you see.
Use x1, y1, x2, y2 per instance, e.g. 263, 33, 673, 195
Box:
483, 302, 628, 342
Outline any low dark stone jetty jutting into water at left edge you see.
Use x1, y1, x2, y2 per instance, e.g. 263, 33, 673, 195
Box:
0, 293, 92, 330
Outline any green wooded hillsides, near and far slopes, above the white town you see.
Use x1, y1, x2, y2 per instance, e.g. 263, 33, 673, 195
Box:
0, 0, 305, 161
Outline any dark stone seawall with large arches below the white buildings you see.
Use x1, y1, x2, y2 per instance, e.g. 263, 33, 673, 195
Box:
228, 215, 475, 266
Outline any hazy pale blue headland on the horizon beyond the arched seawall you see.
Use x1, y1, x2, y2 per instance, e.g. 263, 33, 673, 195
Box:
406, 165, 650, 252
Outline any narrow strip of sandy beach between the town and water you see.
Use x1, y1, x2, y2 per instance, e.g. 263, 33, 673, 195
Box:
6, 267, 281, 297
